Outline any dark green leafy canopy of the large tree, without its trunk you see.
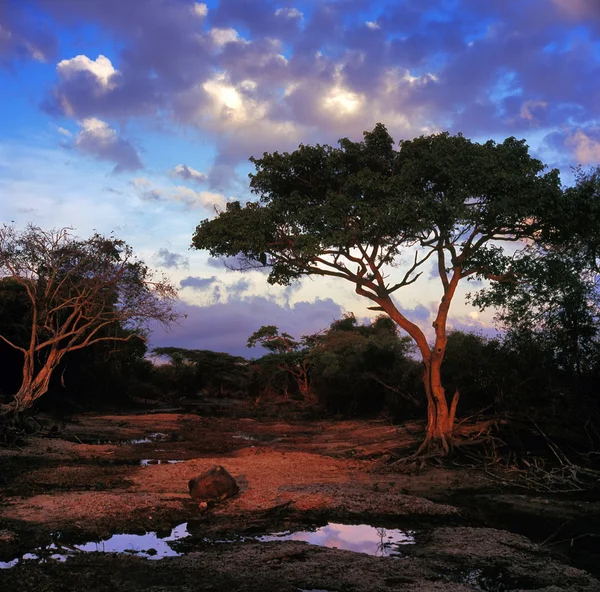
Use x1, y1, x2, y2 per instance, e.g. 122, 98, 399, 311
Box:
193, 124, 562, 293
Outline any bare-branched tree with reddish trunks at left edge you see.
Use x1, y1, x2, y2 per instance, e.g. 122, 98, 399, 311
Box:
0, 226, 177, 417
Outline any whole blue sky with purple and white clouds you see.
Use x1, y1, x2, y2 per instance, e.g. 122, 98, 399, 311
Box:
0, 0, 600, 356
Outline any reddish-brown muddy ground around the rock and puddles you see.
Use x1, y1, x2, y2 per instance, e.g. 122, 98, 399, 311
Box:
0, 414, 600, 592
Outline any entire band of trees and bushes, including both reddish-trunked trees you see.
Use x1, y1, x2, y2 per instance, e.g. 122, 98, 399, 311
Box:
0, 124, 600, 453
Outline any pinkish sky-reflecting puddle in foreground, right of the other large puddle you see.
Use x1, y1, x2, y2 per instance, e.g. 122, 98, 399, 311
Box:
255, 522, 415, 557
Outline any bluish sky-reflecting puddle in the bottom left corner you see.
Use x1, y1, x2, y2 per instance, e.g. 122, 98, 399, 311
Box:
0, 522, 190, 569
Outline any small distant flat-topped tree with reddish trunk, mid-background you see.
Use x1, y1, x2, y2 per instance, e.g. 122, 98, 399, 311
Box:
247, 325, 317, 402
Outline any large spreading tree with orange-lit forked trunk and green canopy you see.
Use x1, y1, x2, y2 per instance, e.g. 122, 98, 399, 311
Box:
192, 124, 565, 451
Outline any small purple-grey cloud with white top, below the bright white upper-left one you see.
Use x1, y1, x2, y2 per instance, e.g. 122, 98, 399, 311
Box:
74, 117, 144, 173
